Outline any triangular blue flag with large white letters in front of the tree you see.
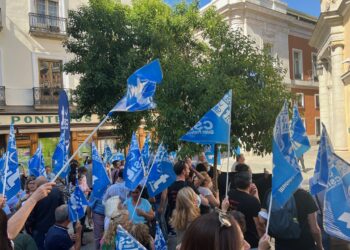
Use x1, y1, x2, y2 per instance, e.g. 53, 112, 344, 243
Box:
180, 90, 232, 144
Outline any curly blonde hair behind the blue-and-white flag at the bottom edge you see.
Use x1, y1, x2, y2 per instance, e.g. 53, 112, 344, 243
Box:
101, 209, 130, 250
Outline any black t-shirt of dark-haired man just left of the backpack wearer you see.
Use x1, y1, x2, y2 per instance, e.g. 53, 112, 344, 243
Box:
228, 189, 261, 248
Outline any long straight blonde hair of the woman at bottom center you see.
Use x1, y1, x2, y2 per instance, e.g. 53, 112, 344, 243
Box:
170, 187, 200, 244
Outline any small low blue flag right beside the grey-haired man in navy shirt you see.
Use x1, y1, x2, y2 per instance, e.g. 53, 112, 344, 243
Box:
68, 186, 88, 222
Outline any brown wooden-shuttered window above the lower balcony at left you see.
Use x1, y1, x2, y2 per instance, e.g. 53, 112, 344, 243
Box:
39, 59, 63, 88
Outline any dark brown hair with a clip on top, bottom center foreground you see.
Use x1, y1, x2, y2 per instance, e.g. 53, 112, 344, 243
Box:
180, 213, 241, 250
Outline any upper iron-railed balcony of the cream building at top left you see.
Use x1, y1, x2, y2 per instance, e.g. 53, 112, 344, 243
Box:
29, 13, 67, 39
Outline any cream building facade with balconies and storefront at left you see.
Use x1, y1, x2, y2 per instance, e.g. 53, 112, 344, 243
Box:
0, 0, 115, 165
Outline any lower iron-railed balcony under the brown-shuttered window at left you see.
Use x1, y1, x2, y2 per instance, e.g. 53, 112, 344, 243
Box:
33, 87, 73, 109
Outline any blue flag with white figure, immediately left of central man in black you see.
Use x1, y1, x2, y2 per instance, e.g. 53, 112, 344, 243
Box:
147, 144, 176, 197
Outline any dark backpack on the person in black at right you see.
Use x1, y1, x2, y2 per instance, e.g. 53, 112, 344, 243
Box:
266, 193, 301, 239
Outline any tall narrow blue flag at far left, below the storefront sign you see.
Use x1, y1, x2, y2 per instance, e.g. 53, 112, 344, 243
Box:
0, 124, 21, 200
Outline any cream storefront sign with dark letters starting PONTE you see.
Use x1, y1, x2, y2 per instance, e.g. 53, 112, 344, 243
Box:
0, 115, 100, 126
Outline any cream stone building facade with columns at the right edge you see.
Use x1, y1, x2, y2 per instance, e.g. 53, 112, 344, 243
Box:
310, 0, 350, 151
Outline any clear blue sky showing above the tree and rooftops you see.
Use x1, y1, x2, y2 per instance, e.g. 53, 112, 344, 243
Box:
165, 0, 320, 17
